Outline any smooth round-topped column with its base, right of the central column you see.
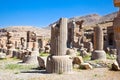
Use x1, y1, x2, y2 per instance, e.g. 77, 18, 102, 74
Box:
91, 26, 106, 60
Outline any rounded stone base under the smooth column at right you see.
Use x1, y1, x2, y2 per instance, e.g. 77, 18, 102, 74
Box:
91, 50, 106, 60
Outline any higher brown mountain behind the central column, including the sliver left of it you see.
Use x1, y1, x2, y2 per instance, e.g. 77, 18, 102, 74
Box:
48, 12, 117, 29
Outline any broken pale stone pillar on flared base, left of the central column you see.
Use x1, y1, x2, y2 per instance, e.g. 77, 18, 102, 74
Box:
23, 31, 39, 64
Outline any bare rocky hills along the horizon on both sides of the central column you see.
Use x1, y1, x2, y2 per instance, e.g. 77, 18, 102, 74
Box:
0, 12, 117, 37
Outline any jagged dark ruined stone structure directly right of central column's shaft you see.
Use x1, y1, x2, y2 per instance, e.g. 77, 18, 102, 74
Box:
67, 20, 86, 48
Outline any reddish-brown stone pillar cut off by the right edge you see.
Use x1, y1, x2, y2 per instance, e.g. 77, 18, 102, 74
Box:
113, 15, 120, 67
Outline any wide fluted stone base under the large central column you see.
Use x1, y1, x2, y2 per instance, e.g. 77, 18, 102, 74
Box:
46, 56, 72, 74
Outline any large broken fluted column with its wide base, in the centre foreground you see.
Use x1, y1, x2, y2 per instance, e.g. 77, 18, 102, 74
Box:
46, 18, 72, 73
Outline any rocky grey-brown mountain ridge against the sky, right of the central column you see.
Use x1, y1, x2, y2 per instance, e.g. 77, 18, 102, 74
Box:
69, 12, 117, 26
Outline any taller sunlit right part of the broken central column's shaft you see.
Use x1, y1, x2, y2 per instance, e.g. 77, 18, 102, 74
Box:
57, 18, 67, 56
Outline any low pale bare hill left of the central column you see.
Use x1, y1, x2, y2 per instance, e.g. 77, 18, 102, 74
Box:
0, 26, 50, 37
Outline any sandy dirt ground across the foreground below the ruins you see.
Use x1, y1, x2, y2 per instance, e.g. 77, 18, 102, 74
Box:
0, 60, 120, 80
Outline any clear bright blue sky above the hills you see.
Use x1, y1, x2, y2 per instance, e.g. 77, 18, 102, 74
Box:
0, 0, 118, 27
